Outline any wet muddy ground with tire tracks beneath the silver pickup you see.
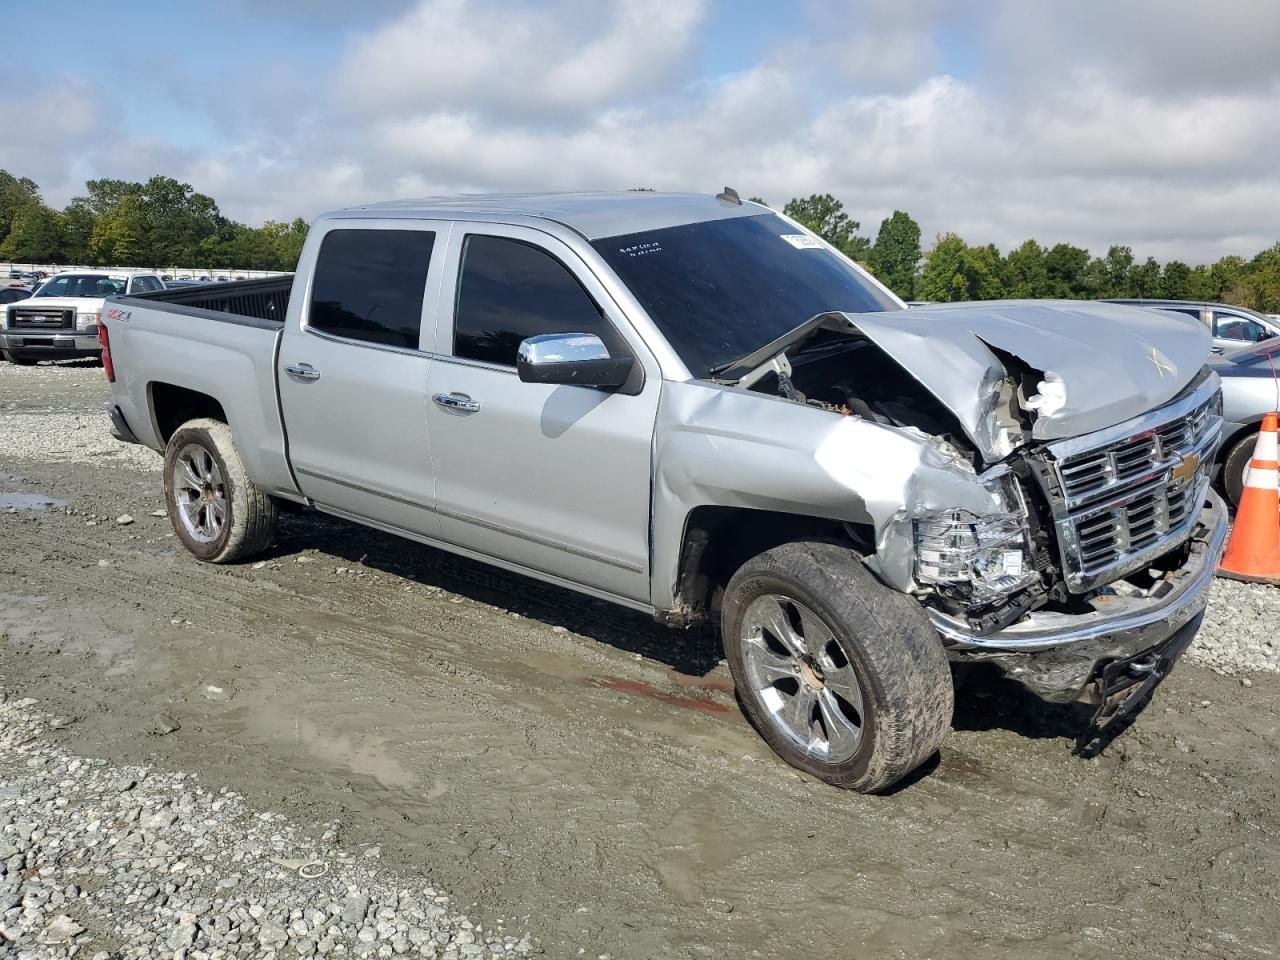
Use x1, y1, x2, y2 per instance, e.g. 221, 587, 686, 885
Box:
0, 364, 1280, 960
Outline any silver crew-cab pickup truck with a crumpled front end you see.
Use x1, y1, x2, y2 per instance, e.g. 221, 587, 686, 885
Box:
101, 191, 1226, 791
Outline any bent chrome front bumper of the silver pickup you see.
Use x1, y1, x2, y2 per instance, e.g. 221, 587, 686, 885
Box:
929, 490, 1228, 703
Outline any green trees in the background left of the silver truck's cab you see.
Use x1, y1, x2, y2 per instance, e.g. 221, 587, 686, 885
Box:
0, 170, 307, 270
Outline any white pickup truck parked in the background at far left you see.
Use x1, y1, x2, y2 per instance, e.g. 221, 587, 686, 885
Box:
0, 270, 164, 365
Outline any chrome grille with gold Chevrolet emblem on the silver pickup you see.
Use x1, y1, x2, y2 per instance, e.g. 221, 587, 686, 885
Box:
1046, 376, 1222, 593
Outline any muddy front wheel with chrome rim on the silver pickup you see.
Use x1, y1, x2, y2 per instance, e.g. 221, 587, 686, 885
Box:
721, 543, 955, 794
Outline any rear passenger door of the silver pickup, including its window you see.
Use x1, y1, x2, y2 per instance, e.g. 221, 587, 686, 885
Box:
276, 220, 448, 536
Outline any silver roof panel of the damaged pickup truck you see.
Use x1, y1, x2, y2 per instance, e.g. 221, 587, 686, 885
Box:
324, 191, 771, 239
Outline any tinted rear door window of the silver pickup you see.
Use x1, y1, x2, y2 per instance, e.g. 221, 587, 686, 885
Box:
308, 230, 435, 348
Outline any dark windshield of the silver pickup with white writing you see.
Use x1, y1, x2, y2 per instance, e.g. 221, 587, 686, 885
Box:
591, 214, 900, 378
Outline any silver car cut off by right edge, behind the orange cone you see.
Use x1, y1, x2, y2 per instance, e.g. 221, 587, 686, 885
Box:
1212, 339, 1280, 507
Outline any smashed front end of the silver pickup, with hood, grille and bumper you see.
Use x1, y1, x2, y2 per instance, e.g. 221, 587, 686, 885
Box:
739, 303, 1226, 716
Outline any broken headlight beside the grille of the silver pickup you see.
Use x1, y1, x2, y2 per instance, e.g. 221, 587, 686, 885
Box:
915, 476, 1038, 603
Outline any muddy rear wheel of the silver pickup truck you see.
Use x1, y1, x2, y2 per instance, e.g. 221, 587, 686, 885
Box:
164, 420, 276, 563
